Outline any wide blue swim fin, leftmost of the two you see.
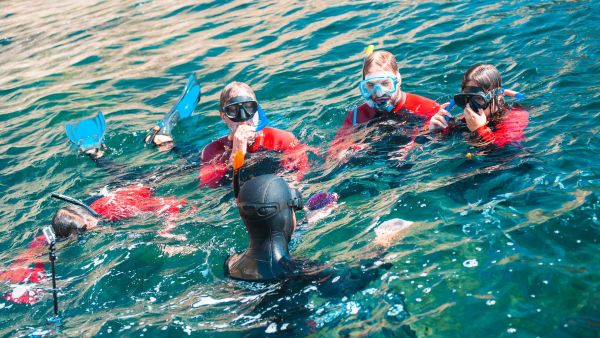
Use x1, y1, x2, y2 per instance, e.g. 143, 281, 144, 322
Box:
65, 112, 106, 151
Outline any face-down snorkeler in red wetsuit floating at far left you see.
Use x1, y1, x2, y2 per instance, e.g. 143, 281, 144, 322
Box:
0, 185, 186, 304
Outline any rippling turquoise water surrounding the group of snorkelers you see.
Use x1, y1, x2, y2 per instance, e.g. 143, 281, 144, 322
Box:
0, 1, 600, 337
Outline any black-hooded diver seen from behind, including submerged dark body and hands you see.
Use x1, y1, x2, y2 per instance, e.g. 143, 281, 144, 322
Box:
224, 175, 414, 337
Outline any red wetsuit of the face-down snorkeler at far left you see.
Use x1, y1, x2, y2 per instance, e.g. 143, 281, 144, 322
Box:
0, 185, 186, 304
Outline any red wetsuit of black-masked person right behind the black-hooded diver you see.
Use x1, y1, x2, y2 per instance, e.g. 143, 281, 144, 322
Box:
198, 127, 310, 188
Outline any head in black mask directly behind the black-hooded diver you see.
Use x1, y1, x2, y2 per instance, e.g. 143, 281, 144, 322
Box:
219, 81, 258, 134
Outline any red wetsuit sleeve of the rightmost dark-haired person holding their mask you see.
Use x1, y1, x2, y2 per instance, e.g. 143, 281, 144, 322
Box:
475, 109, 529, 147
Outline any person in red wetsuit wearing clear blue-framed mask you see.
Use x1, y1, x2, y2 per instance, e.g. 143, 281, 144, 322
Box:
329, 51, 444, 159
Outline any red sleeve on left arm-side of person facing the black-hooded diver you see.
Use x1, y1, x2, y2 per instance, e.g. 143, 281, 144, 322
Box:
198, 140, 229, 188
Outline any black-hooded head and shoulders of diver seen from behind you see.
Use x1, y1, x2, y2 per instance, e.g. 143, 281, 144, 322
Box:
225, 175, 305, 282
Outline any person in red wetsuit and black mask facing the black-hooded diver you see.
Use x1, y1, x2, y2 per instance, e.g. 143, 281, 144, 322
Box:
199, 81, 310, 187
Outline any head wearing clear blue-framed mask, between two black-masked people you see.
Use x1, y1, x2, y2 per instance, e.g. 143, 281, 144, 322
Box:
360, 51, 402, 111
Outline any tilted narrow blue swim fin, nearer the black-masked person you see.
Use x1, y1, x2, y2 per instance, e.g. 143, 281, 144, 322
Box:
159, 73, 200, 135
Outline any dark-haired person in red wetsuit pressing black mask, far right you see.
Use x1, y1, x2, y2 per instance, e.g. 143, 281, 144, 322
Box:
430, 64, 529, 147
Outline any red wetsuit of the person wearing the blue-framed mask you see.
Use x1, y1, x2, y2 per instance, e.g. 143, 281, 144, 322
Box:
329, 92, 440, 156
